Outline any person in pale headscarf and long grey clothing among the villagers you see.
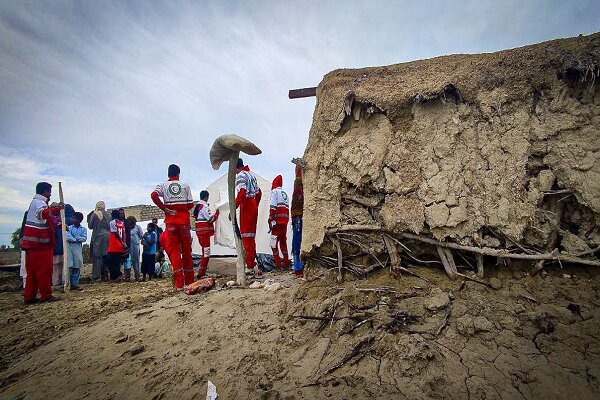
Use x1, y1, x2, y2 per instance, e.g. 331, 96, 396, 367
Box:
87, 201, 110, 282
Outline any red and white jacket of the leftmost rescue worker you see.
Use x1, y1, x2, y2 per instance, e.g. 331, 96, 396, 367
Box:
21, 194, 60, 250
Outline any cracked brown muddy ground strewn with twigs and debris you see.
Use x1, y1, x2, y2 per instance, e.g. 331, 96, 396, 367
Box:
0, 260, 600, 399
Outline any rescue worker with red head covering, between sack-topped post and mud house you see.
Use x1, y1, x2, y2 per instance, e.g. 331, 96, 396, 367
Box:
269, 175, 290, 269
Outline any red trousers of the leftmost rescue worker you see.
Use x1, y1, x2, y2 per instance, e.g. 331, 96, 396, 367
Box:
23, 246, 52, 302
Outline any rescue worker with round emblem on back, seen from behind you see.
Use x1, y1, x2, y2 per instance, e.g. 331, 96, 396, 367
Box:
150, 164, 194, 290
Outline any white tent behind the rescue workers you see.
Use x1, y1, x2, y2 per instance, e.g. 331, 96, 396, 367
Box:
192, 173, 292, 258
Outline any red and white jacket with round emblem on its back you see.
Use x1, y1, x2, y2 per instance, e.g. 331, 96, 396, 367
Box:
150, 176, 194, 225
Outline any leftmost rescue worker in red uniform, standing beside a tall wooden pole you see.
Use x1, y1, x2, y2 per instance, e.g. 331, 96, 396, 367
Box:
21, 182, 64, 304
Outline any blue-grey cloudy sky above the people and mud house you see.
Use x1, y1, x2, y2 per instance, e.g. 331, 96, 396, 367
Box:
0, 0, 600, 244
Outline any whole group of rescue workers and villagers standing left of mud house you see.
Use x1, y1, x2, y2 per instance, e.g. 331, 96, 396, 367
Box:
21, 158, 304, 304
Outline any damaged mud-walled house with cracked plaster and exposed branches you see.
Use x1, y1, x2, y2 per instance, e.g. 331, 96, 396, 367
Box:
302, 33, 600, 276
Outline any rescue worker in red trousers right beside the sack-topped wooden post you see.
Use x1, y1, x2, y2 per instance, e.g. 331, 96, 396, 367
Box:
235, 158, 262, 276
